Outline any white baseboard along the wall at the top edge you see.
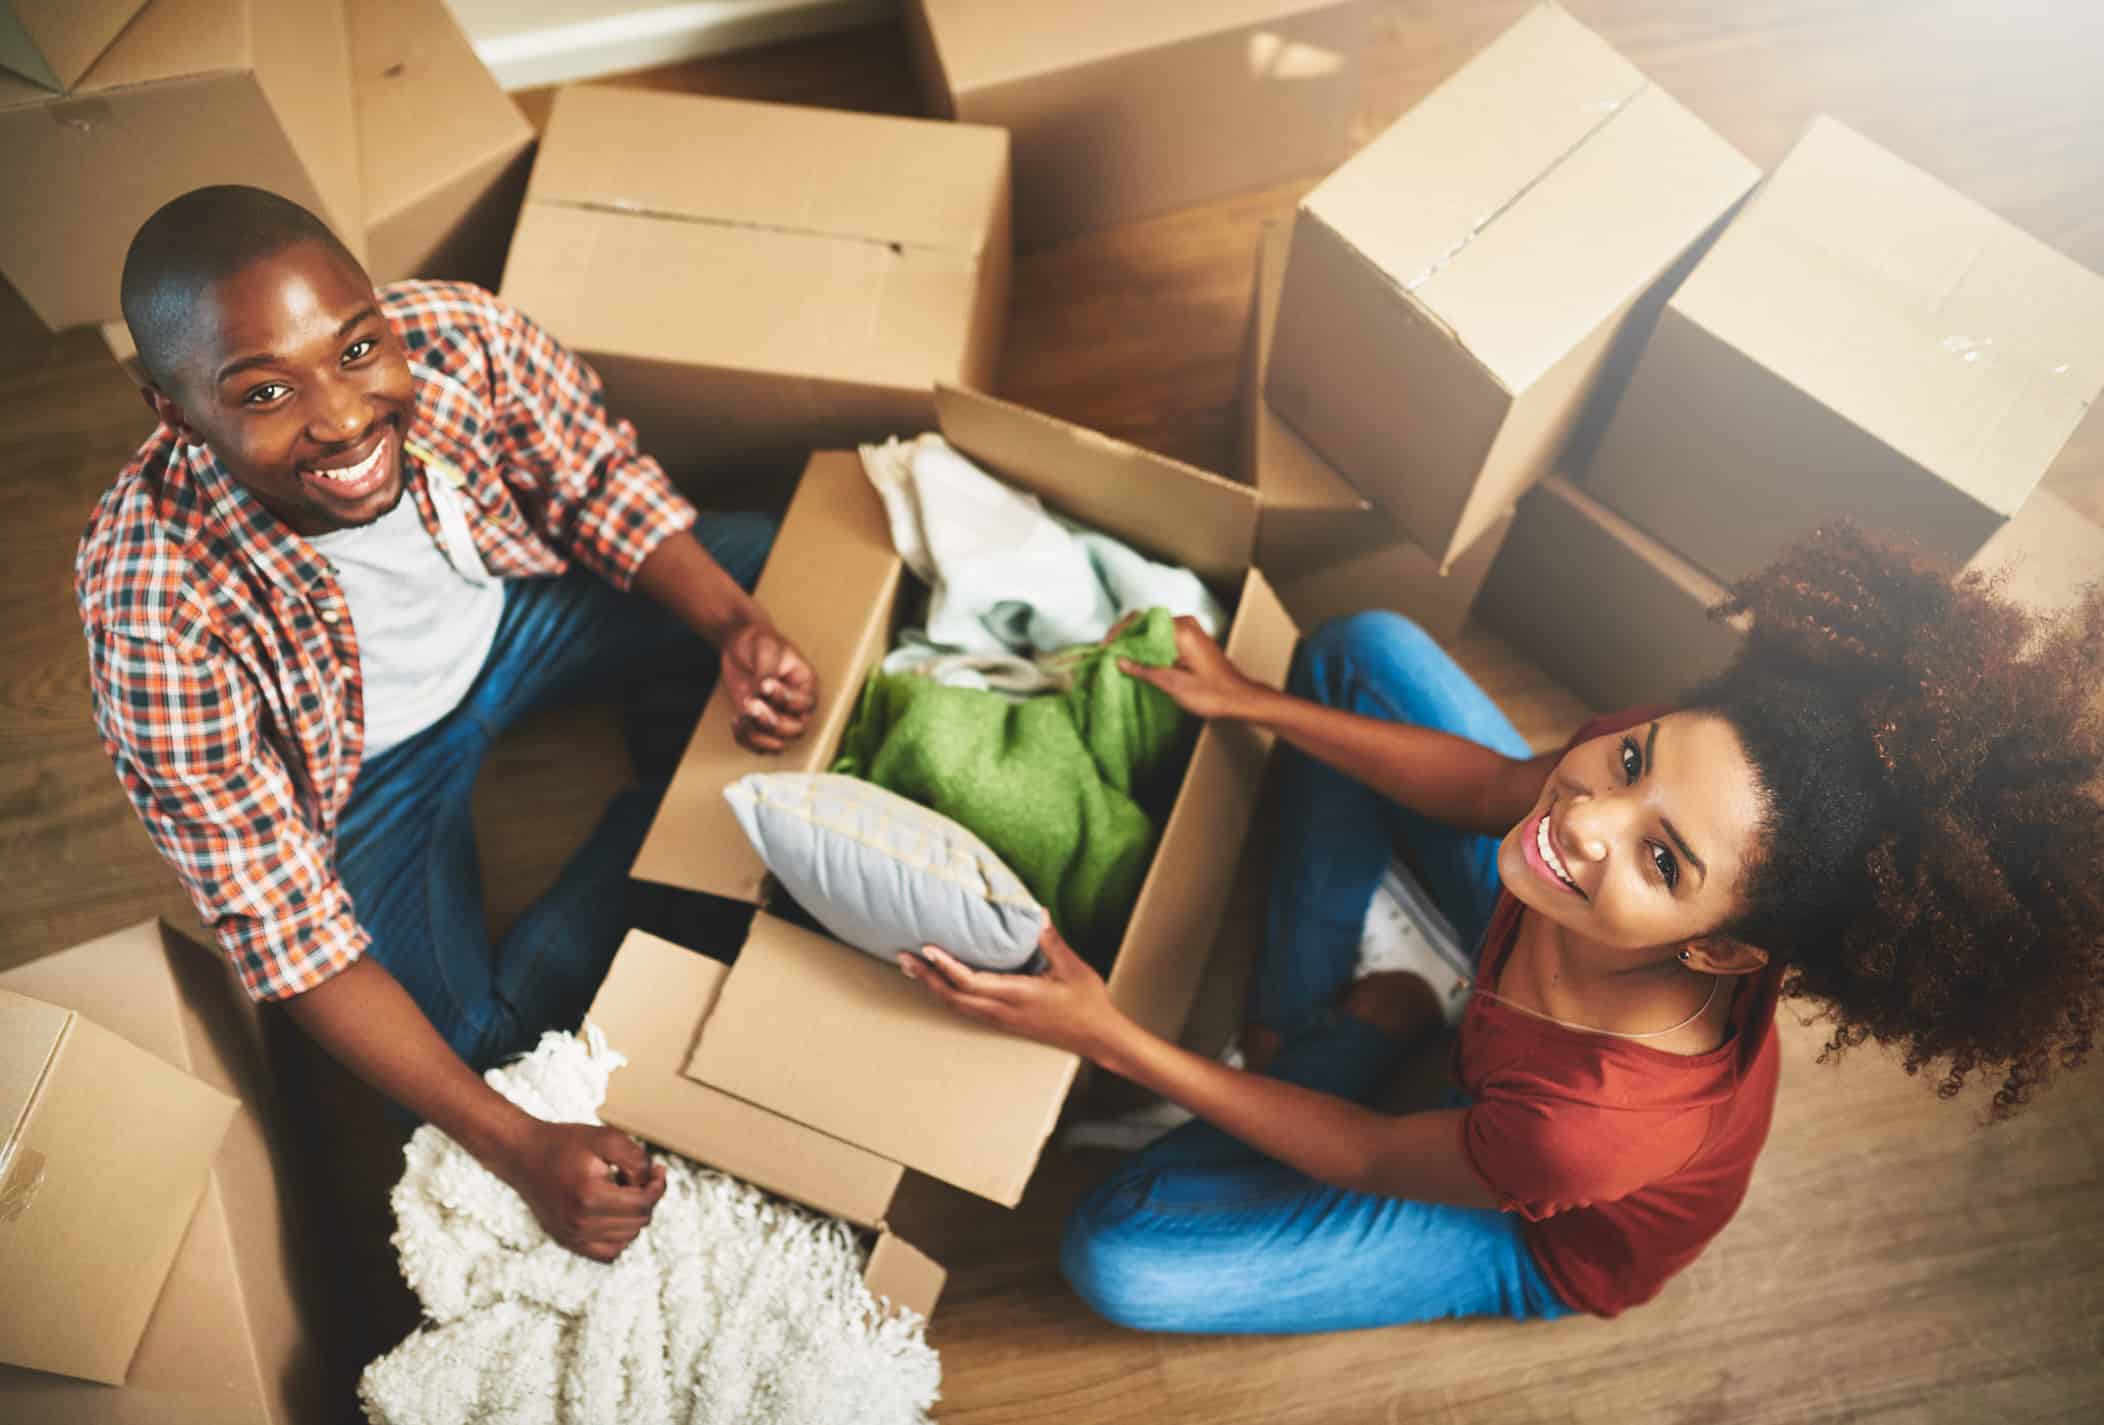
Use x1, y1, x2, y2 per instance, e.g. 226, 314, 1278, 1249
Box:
448, 0, 898, 88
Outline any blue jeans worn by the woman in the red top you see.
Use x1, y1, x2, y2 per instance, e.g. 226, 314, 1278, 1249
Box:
1060, 613, 1570, 1334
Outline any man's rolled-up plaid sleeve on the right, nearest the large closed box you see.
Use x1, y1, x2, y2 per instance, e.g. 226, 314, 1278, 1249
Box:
490, 303, 694, 589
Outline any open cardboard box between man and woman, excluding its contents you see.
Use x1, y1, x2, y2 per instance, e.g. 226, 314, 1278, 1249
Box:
614, 387, 1296, 1217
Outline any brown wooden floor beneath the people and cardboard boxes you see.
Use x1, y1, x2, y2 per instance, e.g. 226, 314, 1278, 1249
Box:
0, 0, 2104, 1425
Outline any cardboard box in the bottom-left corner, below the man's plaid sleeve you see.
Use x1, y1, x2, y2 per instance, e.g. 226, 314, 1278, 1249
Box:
0, 922, 330, 1425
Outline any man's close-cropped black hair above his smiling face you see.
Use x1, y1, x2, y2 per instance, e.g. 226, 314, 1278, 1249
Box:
122, 183, 364, 389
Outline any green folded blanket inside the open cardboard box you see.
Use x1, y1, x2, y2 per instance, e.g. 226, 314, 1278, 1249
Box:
833, 608, 1185, 966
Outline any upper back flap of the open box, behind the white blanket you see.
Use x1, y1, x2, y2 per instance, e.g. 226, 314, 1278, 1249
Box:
934, 385, 1258, 594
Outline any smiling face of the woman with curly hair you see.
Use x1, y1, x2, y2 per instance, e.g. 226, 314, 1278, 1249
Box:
1498, 714, 1761, 951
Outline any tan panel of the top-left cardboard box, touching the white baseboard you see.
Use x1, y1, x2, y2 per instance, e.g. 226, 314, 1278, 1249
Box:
343, 0, 532, 227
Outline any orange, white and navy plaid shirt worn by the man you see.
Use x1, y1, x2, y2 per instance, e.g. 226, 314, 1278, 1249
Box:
74, 282, 694, 1000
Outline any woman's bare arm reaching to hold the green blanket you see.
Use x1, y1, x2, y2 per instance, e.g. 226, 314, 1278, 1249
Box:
1119, 619, 1557, 836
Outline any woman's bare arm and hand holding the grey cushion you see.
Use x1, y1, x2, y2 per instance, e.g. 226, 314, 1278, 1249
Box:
898, 926, 1496, 1208
